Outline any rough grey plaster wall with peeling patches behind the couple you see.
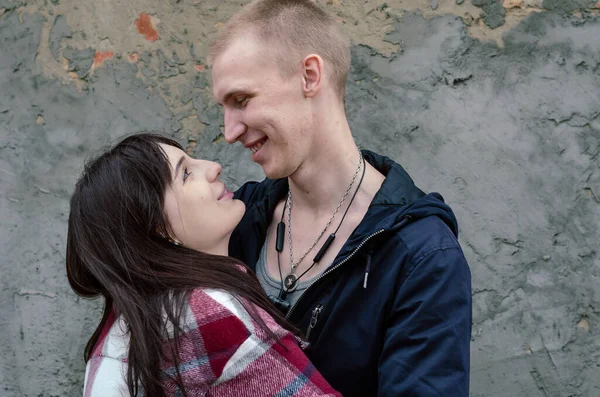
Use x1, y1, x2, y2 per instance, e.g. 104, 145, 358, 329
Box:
0, 0, 600, 397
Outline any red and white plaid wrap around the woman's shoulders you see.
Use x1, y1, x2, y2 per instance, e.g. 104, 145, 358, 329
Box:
84, 289, 340, 397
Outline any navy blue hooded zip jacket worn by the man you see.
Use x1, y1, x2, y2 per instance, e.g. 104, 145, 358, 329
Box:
229, 151, 471, 397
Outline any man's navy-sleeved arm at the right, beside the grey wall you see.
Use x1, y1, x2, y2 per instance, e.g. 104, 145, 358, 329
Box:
378, 246, 472, 397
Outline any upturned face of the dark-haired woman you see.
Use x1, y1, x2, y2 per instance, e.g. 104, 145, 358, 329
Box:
160, 144, 245, 255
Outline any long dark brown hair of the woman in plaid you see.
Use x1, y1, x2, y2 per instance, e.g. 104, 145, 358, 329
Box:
66, 133, 290, 397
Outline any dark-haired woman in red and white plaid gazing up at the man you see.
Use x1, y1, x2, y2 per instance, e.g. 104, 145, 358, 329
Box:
66, 134, 337, 397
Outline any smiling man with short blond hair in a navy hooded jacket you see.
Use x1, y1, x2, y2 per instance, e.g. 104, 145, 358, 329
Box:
211, 0, 471, 397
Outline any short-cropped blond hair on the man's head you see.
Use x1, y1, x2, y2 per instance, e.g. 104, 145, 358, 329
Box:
210, 0, 350, 100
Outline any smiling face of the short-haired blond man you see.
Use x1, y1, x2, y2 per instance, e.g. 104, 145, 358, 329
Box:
212, 35, 311, 179
